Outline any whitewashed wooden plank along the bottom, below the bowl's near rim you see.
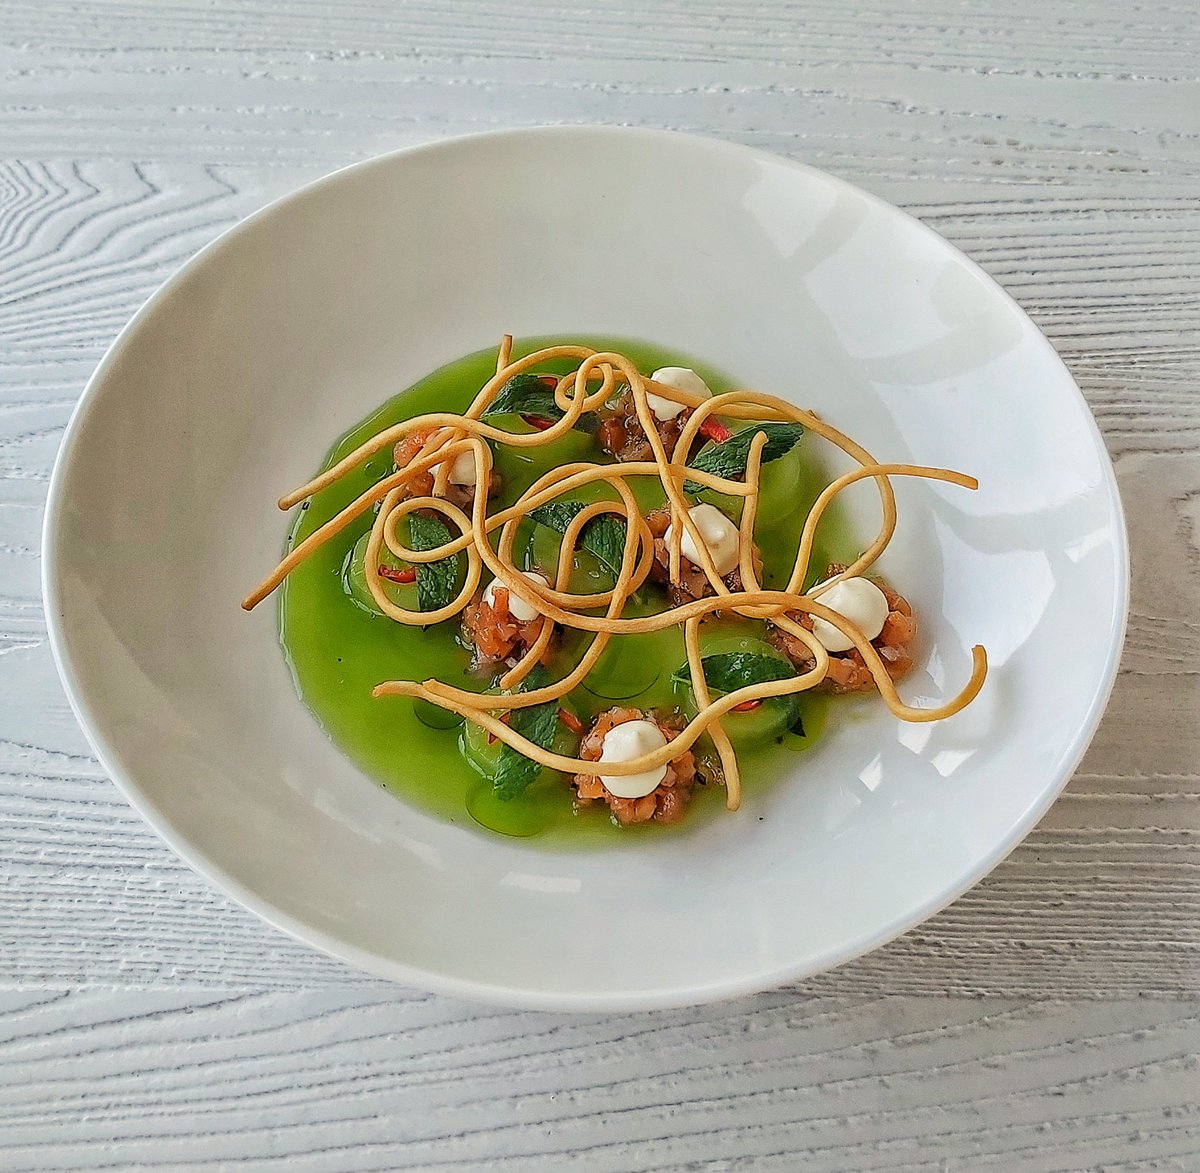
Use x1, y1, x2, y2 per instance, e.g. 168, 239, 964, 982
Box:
0, 991, 1200, 1173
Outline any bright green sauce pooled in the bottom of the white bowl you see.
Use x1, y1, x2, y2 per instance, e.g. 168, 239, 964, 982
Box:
278, 338, 859, 847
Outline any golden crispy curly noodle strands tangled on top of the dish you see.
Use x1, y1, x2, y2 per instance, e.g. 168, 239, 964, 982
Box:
242, 336, 988, 811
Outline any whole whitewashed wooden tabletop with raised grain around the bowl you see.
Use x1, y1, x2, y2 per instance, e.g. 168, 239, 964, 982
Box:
0, 0, 1200, 1171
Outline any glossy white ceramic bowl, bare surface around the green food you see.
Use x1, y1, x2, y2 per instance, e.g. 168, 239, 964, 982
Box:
44, 128, 1127, 1009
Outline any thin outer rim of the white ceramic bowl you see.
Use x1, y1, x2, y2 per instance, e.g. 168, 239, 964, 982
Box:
41, 124, 1130, 1012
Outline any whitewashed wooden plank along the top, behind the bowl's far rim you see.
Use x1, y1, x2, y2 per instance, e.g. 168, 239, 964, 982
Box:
0, 0, 1200, 198
